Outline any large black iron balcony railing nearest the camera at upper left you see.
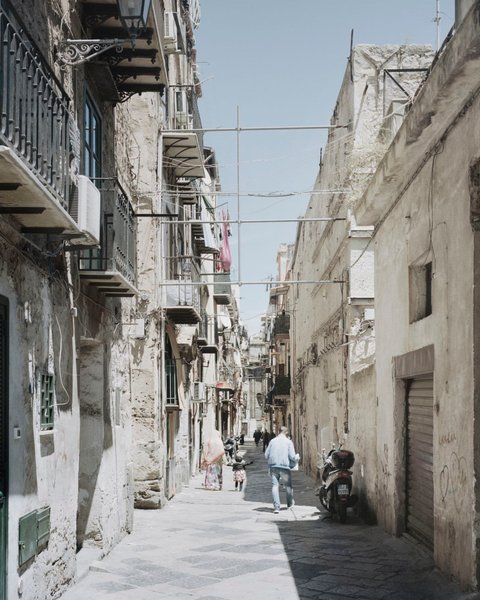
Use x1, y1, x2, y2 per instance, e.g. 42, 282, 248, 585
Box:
0, 0, 73, 206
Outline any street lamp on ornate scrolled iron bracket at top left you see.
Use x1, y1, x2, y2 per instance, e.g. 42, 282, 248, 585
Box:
56, 0, 152, 69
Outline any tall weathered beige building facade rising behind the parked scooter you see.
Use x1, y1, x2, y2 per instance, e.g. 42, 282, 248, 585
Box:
286, 45, 432, 517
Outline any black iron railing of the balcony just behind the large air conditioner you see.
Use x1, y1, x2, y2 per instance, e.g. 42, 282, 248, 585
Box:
79, 178, 137, 287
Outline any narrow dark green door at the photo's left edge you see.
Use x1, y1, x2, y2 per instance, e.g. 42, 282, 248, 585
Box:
0, 296, 8, 600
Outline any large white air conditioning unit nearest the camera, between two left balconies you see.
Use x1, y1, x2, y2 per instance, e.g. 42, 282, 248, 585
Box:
70, 175, 102, 246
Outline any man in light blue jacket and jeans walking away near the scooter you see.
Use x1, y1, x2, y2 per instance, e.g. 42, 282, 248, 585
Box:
265, 427, 298, 514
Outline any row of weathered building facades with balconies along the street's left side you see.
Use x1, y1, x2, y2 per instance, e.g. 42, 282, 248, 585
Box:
0, 0, 244, 600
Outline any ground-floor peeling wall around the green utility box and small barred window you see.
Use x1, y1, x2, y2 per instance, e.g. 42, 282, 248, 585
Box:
0, 227, 79, 600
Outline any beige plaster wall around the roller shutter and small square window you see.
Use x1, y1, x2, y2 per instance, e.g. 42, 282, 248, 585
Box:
376, 86, 480, 586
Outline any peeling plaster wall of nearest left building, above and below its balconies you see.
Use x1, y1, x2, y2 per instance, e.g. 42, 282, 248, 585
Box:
0, 0, 137, 600
